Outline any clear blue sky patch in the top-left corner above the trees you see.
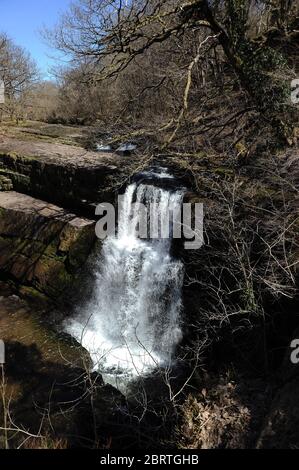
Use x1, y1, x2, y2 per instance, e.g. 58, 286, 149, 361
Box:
0, 0, 71, 79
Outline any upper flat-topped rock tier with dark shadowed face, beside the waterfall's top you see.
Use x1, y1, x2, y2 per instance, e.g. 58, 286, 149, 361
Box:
0, 137, 126, 217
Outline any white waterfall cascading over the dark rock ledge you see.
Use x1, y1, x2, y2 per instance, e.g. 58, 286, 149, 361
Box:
67, 169, 183, 375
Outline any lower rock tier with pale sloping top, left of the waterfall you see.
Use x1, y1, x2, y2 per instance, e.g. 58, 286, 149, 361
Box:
0, 191, 96, 300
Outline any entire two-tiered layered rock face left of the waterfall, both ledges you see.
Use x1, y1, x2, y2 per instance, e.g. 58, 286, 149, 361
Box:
0, 125, 135, 300
